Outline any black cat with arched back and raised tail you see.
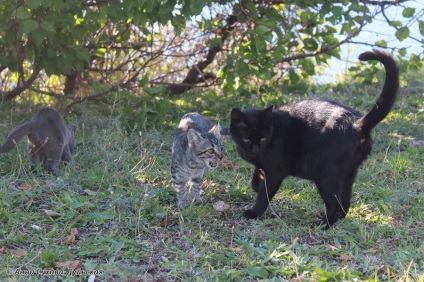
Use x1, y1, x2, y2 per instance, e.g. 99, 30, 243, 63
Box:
230, 50, 399, 228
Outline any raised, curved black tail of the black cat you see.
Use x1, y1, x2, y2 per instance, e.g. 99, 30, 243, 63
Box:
356, 50, 399, 133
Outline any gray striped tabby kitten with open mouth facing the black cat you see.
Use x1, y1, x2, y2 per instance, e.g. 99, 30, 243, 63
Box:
171, 113, 224, 207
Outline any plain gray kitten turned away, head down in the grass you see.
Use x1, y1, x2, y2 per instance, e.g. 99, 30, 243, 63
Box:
0, 108, 77, 173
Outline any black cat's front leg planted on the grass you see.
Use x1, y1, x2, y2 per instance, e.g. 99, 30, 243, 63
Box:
243, 171, 284, 219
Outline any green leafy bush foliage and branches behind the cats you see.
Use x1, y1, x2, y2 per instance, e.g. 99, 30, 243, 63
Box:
0, 0, 424, 105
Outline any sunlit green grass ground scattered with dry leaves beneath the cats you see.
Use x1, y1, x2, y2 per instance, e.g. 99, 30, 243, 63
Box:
0, 80, 424, 281
